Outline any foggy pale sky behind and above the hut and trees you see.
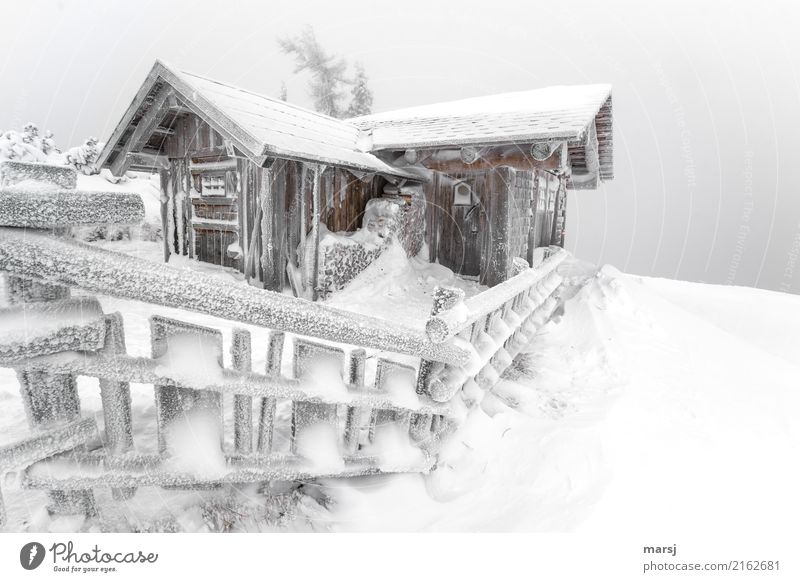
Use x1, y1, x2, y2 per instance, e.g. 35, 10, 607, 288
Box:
0, 0, 800, 293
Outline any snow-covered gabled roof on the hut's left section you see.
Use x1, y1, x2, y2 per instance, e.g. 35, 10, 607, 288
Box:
100, 61, 416, 176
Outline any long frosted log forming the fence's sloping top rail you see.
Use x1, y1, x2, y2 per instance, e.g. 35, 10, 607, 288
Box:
0, 228, 471, 364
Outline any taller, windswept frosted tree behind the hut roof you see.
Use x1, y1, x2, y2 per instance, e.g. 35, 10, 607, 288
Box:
278, 27, 349, 117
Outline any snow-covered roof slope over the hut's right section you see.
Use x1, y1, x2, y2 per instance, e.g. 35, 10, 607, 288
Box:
348, 85, 611, 151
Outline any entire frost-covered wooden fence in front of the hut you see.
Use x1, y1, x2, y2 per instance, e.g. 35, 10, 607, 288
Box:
0, 162, 565, 521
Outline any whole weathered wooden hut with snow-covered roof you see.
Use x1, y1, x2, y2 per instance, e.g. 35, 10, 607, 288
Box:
98, 61, 613, 297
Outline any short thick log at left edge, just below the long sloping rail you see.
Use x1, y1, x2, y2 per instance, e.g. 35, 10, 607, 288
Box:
0, 297, 106, 362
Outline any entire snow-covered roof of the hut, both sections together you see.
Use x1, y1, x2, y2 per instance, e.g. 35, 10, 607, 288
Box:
97, 61, 613, 185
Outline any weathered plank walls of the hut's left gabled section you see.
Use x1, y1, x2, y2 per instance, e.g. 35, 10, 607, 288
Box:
158, 113, 386, 290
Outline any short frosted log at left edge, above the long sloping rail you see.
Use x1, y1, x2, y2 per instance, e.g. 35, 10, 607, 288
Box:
0, 186, 144, 228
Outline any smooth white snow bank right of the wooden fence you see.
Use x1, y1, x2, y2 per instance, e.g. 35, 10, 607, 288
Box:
318, 263, 800, 535
